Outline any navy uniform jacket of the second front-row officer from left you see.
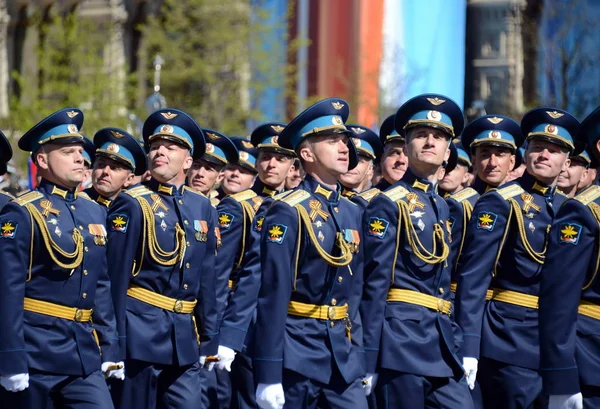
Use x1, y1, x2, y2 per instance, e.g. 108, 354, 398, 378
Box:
107, 179, 218, 366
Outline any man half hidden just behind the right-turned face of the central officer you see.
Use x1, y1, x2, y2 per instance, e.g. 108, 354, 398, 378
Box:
340, 125, 383, 210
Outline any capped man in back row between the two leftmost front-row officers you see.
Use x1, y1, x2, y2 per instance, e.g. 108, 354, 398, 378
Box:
85, 128, 147, 211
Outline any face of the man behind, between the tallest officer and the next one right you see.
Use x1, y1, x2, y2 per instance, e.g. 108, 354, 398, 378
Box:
473, 145, 515, 186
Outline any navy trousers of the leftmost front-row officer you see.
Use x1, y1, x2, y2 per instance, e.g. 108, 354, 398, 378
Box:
0, 369, 114, 409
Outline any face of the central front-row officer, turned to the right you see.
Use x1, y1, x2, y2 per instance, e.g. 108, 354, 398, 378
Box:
300, 134, 350, 179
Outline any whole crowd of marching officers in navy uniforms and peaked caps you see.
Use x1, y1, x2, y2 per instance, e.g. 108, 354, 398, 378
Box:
0, 94, 600, 409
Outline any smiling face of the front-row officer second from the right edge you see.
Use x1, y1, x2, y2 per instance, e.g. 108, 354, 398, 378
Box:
525, 139, 571, 184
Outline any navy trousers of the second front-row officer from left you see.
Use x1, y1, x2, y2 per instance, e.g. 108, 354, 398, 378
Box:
117, 359, 203, 409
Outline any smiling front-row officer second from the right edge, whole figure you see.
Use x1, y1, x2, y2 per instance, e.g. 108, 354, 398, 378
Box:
455, 108, 580, 409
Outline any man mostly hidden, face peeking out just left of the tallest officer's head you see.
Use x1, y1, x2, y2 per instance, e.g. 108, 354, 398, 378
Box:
375, 115, 408, 191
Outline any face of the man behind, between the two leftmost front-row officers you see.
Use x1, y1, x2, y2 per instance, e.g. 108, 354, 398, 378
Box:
92, 156, 133, 199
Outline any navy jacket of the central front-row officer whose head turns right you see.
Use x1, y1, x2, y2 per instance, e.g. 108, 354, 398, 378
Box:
253, 175, 364, 384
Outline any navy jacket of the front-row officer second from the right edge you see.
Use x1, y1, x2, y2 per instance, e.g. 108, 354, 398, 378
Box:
455, 172, 566, 369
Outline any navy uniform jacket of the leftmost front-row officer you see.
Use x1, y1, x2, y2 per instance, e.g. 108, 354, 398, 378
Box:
0, 180, 118, 376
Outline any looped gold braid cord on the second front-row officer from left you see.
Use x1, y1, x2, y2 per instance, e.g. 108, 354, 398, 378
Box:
134, 197, 186, 266
